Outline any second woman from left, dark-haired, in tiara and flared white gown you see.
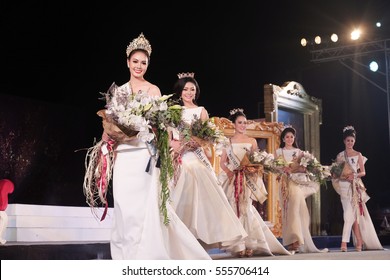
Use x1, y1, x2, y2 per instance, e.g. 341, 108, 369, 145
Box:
171, 73, 246, 254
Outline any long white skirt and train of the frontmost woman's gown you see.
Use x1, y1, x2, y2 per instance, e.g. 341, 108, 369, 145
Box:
110, 140, 211, 260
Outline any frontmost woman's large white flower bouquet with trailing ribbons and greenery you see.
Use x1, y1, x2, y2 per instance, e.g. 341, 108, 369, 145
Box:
84, 83, 182, 224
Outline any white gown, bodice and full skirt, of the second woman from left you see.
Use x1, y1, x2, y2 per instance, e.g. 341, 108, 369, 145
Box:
171, 107, 247, 253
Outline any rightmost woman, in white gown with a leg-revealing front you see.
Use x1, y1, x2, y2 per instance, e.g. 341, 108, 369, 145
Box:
332, 126, 383, 252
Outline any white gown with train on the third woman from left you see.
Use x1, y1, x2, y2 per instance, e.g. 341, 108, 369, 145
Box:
218, 143, 290, 255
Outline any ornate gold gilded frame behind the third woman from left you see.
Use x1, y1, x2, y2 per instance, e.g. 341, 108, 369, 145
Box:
213, 117, 283, 237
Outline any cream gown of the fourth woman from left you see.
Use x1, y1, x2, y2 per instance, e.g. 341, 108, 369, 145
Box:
276, 148, 328, 253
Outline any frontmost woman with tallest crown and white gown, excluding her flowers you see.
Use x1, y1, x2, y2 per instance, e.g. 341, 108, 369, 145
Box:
90, 33, 211, 260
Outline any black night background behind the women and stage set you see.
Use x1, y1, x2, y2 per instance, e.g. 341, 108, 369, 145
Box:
0, 0, 390, 235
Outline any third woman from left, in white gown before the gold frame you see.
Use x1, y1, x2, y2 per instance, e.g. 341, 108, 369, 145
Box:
219, 109, 291, 257
